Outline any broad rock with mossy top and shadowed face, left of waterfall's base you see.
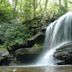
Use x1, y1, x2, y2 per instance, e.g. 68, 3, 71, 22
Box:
15, 48, 40, 64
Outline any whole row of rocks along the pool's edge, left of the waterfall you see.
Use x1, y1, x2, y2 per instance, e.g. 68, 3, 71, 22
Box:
0, 48, 41, 66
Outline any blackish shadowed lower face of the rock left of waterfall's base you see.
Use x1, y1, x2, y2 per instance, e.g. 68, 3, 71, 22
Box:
16, 54, 38, 64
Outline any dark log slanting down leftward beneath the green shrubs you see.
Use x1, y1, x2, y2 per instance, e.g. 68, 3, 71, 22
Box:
7, 32, 44, 54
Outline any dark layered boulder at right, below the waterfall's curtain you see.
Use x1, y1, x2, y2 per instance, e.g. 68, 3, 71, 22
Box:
53, 43, 72, 65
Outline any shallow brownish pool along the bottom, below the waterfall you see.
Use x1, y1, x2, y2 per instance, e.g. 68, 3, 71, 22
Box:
0, 65, 72, 72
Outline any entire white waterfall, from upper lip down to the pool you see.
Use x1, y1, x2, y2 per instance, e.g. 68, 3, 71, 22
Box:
36, 12, 72, 65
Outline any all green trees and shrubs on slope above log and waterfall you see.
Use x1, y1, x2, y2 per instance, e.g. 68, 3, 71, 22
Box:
0, 0, 71, 48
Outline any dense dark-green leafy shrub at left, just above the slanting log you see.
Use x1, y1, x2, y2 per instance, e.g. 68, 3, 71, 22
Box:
0, 21, 32, 47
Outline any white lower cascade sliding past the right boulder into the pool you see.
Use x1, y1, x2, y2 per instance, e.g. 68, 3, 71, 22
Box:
37, 41, 72, 65
